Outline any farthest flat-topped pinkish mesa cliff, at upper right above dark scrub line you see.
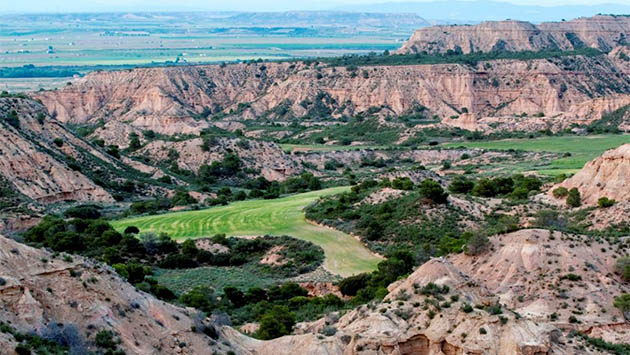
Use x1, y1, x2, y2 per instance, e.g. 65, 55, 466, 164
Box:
398, 16, 630, 53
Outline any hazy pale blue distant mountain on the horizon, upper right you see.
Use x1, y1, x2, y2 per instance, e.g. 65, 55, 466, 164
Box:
335, 0, 630, 23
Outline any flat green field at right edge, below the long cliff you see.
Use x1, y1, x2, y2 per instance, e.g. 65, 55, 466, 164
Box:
444, 134, 630, 175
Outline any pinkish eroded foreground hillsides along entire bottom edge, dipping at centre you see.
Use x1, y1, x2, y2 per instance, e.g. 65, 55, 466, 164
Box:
0, 230, 628, 355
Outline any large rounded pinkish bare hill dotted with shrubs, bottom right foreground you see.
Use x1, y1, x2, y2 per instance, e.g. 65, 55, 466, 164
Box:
235, 229, 630, 355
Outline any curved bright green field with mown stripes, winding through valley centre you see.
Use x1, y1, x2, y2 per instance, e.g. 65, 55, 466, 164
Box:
112, 187, 380, 276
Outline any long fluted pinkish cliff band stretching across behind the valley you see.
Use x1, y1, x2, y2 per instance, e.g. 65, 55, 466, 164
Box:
33, 50, 630, 139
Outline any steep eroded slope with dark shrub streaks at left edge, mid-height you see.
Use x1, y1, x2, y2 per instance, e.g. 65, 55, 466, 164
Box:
0, 98, 113, 203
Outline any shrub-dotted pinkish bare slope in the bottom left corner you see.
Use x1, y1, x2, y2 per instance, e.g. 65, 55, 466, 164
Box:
0, 236, 242, 354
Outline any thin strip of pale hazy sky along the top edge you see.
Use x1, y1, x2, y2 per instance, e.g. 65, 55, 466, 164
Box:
0, 0, 628, 12
